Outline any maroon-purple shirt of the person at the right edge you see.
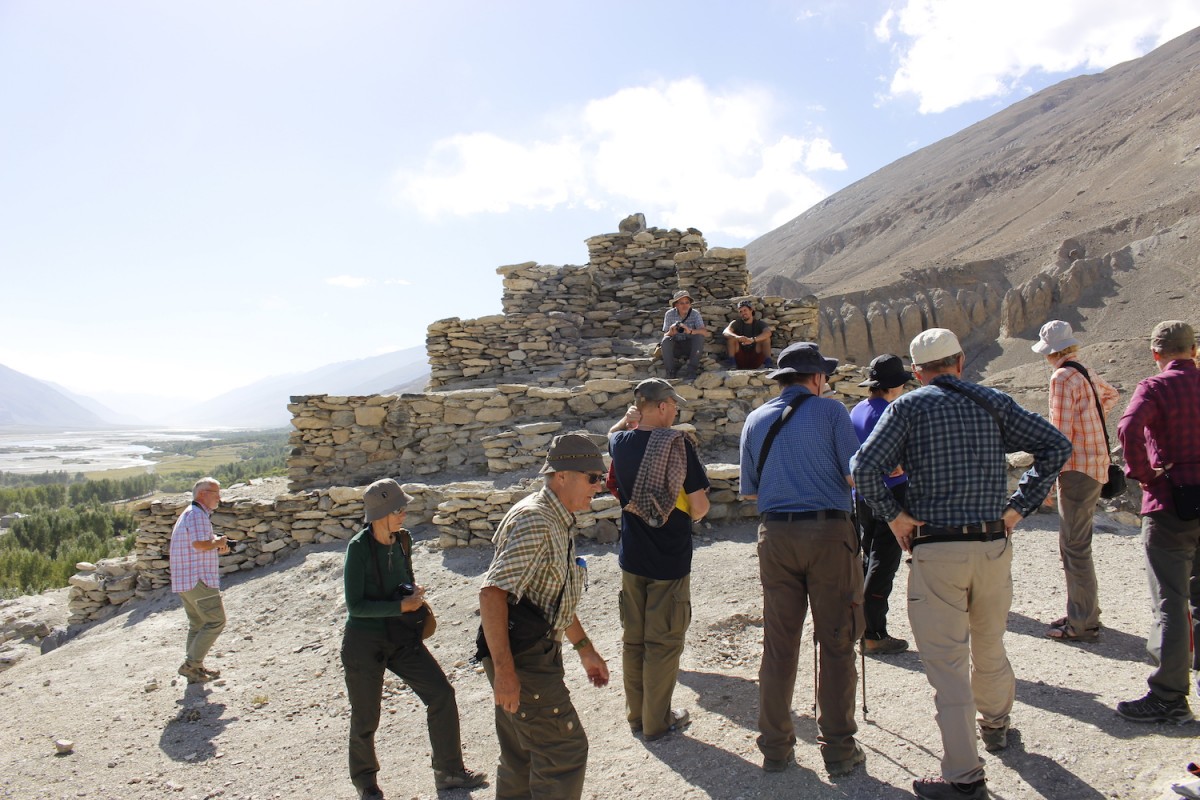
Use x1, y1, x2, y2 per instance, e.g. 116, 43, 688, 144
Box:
1117, 359, 1200, 515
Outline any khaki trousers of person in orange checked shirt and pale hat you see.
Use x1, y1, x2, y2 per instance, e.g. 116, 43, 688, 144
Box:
1058, 470, 1102, 633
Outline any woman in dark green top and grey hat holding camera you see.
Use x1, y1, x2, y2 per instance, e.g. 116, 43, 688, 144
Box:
342, 479, 487, 800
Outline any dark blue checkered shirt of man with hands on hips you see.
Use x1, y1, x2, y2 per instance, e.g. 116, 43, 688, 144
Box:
851, 375, 1070, 525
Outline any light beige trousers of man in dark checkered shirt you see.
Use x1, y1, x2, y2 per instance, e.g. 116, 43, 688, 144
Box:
908, 539, 1016, 783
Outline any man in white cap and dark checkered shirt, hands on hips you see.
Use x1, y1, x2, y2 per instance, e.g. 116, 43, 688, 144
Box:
854, 327, 1070, 800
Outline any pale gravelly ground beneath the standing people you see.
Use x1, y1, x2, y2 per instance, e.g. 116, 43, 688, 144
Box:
0, 515, 1200, 800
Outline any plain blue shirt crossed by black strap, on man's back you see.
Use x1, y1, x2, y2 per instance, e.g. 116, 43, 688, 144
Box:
740, 386, 858, 512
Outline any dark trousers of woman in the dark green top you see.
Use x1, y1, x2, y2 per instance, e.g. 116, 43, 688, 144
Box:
342, 627, 462, 790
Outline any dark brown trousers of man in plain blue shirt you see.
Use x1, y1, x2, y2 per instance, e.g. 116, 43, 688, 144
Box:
758, 519, 863, 763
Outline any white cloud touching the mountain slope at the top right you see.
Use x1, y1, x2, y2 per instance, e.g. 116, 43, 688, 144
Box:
875, 0, 1200, 114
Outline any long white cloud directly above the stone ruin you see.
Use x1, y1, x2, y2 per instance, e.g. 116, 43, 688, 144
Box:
396, 78, 846, 239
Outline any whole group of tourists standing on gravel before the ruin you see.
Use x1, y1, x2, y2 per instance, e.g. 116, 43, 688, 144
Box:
172, 316, 1200, 800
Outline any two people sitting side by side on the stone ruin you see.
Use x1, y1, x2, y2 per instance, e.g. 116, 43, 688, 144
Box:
659, 289, 773, 380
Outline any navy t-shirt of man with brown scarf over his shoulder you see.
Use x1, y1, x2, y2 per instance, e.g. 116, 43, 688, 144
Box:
608, 429, 708, 581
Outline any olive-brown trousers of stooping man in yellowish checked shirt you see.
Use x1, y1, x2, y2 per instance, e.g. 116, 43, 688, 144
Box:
484, 639, 588, 800
